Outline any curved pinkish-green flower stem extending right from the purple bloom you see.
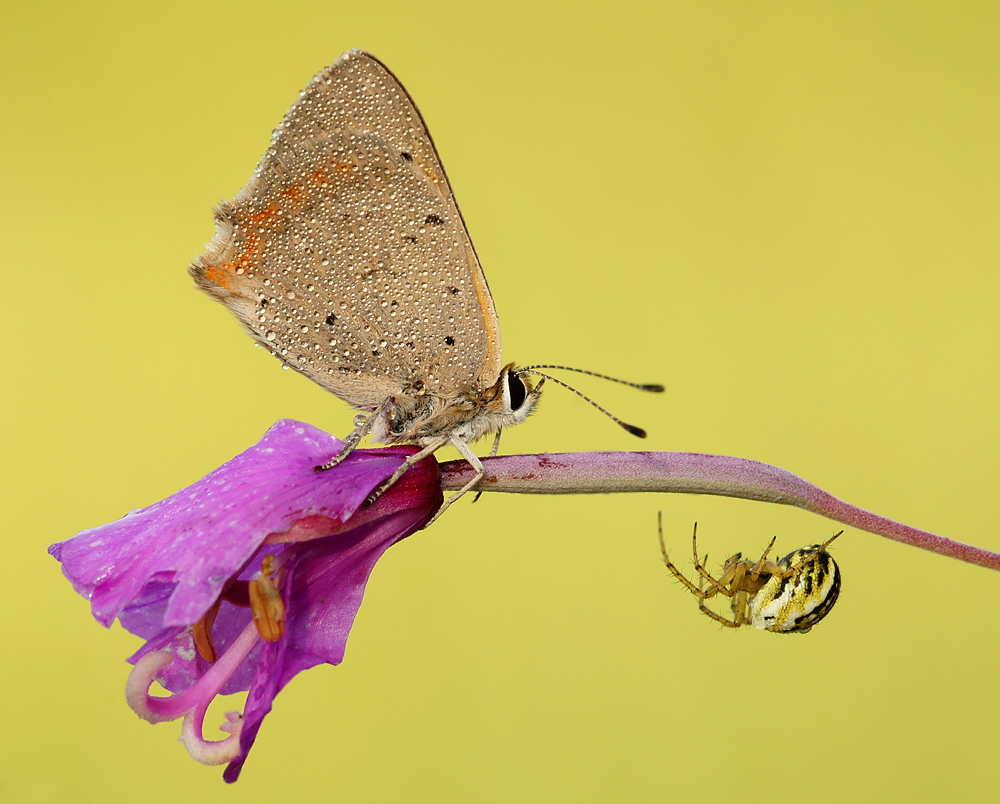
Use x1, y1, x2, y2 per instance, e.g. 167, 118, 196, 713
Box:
440, 452, 1000, 570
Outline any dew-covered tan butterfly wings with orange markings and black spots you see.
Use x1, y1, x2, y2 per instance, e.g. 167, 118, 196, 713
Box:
191, 51, 500, 410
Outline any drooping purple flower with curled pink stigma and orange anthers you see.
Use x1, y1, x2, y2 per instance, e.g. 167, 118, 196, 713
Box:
49, 420, 442, 782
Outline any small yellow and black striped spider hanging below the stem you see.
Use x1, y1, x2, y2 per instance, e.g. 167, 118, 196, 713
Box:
658, 514, 843, 634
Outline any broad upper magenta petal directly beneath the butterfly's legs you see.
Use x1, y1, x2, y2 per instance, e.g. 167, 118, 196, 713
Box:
49, 420, 404, 636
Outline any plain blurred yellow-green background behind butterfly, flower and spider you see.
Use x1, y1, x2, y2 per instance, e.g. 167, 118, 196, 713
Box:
0, 0, 1000, 804
